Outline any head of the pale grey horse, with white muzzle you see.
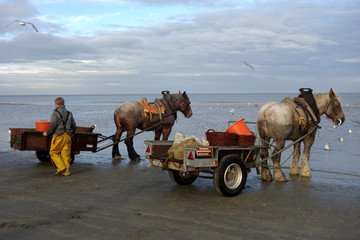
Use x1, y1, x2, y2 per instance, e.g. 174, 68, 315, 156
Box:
325, 89, 345, 125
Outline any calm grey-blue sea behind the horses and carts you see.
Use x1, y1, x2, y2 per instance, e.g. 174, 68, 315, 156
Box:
0, 93, 360, 187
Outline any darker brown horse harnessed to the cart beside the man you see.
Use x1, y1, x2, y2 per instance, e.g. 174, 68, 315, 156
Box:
112, 91, 192, 160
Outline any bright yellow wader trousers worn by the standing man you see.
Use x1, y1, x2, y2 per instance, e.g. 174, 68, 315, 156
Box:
50, 133, 71, 176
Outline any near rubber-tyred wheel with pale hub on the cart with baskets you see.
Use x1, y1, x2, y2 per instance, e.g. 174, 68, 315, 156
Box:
213, 156, 247, 197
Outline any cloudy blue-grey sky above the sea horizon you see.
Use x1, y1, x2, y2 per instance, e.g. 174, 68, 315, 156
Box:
0, 0, 360, 95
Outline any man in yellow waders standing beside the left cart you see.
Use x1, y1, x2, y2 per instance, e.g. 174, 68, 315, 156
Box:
43, 97, 76, 176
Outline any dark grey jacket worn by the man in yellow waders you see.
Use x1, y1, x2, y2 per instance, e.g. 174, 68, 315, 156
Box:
46, 105, 76, 136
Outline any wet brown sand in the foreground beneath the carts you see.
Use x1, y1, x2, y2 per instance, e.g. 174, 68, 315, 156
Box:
0, 151, 360, 240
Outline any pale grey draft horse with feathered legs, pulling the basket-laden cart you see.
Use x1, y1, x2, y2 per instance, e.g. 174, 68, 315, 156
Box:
257, 89, 345, 182
